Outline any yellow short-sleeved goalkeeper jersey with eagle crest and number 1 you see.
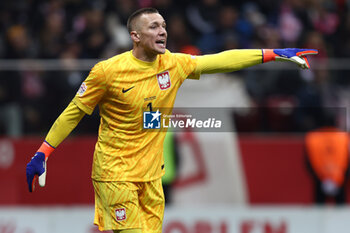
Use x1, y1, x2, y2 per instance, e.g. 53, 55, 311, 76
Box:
73, 51, 200, 182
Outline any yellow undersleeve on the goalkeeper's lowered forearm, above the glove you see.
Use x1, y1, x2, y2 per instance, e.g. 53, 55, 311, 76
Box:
45, 102, 85, 147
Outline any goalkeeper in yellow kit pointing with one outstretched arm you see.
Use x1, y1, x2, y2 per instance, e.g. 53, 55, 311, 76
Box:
26, 8, 317, 233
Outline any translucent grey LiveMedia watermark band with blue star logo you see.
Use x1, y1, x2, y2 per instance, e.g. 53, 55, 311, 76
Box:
142, 107, 347, 133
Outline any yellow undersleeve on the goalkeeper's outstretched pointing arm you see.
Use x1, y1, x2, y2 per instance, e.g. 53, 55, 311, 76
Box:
195, 49, 262, 74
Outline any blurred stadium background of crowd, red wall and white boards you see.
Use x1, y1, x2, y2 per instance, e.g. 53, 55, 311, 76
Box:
0, 0, 350, 233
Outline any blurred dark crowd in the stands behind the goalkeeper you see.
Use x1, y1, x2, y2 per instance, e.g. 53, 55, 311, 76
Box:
0, 0, 350, 136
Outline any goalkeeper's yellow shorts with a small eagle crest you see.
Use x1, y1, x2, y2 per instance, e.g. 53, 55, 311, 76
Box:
93, 179, 165, 233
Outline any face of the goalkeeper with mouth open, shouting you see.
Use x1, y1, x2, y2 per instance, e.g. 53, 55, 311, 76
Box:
135, 13, 168, 54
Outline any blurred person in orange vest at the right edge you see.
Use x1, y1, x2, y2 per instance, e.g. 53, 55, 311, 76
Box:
305, 117, 349, 205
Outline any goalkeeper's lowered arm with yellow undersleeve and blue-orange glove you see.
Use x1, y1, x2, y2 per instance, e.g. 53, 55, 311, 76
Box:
26, 102, 85, 192
